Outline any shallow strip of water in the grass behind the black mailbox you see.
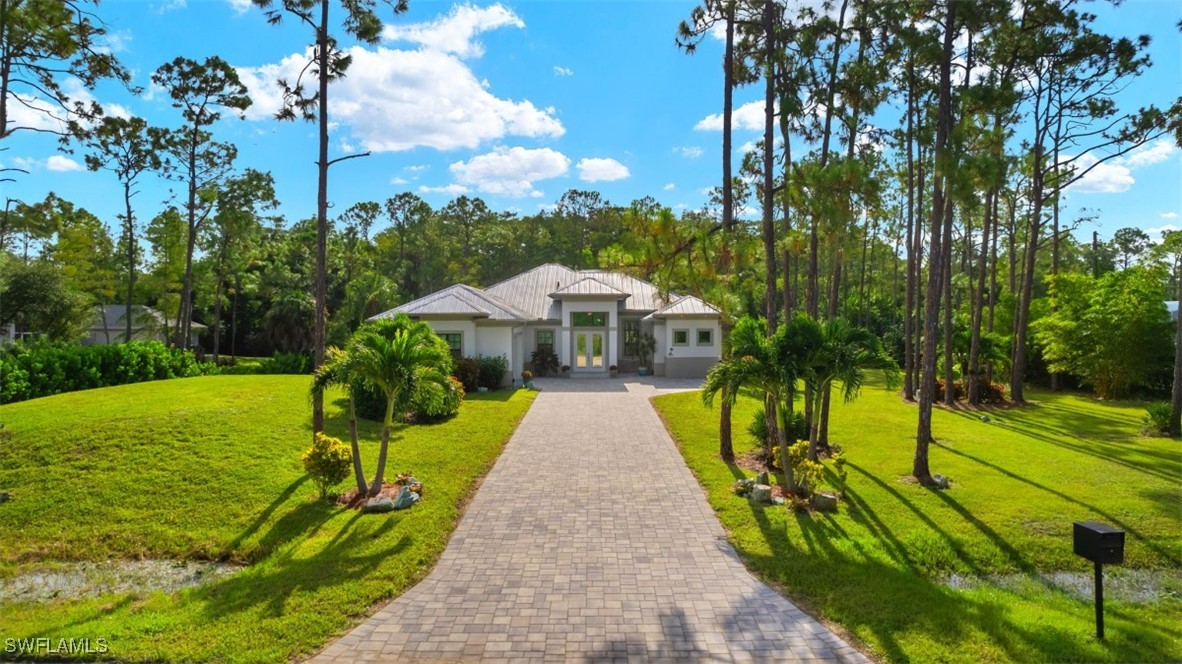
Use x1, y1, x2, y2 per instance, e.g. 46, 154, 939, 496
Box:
942, 567, 1182, 604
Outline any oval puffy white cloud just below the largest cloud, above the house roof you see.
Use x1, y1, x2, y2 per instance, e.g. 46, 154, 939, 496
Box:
448, 147, 567, 198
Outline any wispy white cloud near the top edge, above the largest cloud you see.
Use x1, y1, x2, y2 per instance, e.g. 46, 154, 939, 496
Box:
382, 4, 525, 58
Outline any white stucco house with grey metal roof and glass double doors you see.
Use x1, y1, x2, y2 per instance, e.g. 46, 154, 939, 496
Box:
371, 263, 722, 384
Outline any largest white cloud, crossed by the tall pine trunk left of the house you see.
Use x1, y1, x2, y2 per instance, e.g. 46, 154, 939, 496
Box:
238, 20, 566, 152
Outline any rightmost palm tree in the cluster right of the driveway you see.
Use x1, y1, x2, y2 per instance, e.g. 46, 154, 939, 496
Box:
787, 315, 898, 461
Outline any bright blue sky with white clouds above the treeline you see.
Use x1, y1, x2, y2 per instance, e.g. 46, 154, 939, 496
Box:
0, 0, 1182, 243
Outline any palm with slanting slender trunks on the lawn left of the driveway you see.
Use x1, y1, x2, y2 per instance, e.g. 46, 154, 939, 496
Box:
312, 315, 452, 496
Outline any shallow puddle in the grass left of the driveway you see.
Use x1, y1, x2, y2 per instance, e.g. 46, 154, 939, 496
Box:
0, 560, 243, 604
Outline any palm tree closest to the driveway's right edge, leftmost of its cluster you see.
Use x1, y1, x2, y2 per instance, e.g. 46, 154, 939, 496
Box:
702, 317, 799, 493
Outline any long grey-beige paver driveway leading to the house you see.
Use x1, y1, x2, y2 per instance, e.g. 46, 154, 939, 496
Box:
316, 378, 865, 662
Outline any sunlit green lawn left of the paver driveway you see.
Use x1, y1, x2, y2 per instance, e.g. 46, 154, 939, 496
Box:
0, 376, 533, 662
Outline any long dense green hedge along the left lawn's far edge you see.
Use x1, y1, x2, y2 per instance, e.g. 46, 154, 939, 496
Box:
0, 341, 217, 403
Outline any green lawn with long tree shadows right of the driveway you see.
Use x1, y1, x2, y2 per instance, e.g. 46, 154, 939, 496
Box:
654, 386, 1182, 662
